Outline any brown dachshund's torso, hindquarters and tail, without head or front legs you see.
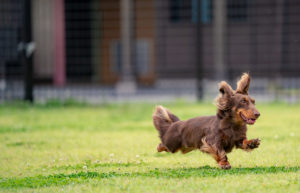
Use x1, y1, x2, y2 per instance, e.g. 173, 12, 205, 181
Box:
152, 106, 216, 153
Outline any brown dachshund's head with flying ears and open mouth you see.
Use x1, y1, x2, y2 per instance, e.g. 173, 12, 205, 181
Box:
217, 73, 260, 125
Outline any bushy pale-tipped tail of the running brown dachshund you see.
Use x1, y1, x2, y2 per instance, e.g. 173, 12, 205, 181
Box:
152, 106, 179, 139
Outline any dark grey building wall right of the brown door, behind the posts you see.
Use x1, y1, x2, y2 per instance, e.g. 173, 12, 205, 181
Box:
156, 0, 300, 79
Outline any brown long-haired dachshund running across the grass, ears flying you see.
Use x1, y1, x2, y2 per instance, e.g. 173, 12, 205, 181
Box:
153, 73, 260, 169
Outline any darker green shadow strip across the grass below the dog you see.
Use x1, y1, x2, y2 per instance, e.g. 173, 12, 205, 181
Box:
0, 166, 300, 188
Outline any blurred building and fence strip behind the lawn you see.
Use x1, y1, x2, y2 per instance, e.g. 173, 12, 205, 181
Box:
0, 0, 300, 103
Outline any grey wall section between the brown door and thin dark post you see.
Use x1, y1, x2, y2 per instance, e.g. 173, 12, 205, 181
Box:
155, 0, 196, 78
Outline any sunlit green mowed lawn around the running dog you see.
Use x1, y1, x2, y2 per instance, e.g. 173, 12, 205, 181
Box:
0, 102, 300, 193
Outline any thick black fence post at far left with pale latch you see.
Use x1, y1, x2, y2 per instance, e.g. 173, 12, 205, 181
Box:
21, 0, 34, 102
